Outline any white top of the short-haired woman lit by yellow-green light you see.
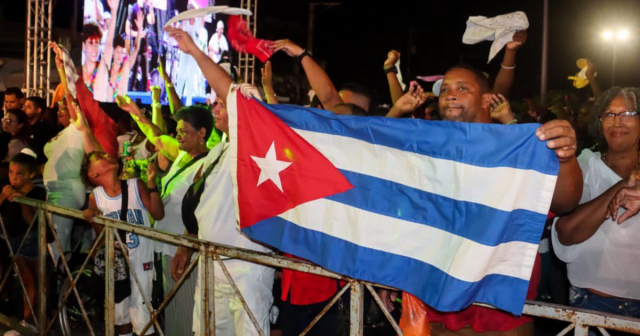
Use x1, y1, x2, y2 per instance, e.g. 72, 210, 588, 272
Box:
155, 151, 205, 256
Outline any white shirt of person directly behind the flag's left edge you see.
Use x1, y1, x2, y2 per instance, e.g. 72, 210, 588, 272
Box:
195, 142, 272, 252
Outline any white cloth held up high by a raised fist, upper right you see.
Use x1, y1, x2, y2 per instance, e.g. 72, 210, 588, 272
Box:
462, 12, 529, 63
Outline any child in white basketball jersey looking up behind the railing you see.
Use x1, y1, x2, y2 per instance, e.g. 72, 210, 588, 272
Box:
80, 152, 164, 335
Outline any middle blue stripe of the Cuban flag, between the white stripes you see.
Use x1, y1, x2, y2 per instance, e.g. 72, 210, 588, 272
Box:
327, 170, 547, 246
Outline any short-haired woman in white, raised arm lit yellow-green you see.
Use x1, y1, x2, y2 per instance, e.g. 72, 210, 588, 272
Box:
120, 98, 213, 335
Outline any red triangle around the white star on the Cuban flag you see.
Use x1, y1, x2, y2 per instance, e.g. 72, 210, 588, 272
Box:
236, 93, 353, 228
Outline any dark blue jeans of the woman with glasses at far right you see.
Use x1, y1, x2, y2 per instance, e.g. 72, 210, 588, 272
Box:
569, 286, 640, 318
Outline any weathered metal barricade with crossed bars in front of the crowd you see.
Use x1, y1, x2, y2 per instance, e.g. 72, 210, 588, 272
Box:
0, 197, 640, 336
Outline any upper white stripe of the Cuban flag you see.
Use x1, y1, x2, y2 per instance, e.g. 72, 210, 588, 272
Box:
293, 129, 556, 215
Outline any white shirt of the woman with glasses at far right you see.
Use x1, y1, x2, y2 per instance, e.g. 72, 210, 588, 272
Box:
551, 149, 640, 300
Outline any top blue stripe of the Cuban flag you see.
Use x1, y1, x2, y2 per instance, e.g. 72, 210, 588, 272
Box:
262, 103, 559, 175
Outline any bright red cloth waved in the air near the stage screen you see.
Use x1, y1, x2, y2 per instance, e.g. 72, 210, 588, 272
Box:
227, 15, 274, 63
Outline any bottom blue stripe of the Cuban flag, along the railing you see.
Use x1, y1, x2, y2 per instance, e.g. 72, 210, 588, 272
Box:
242, 217, 529, 315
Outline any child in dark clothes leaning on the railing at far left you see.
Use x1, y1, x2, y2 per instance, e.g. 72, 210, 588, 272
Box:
0, 149, 47, 335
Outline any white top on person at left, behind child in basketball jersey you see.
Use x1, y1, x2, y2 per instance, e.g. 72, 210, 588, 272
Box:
42, 125, 84, 184
